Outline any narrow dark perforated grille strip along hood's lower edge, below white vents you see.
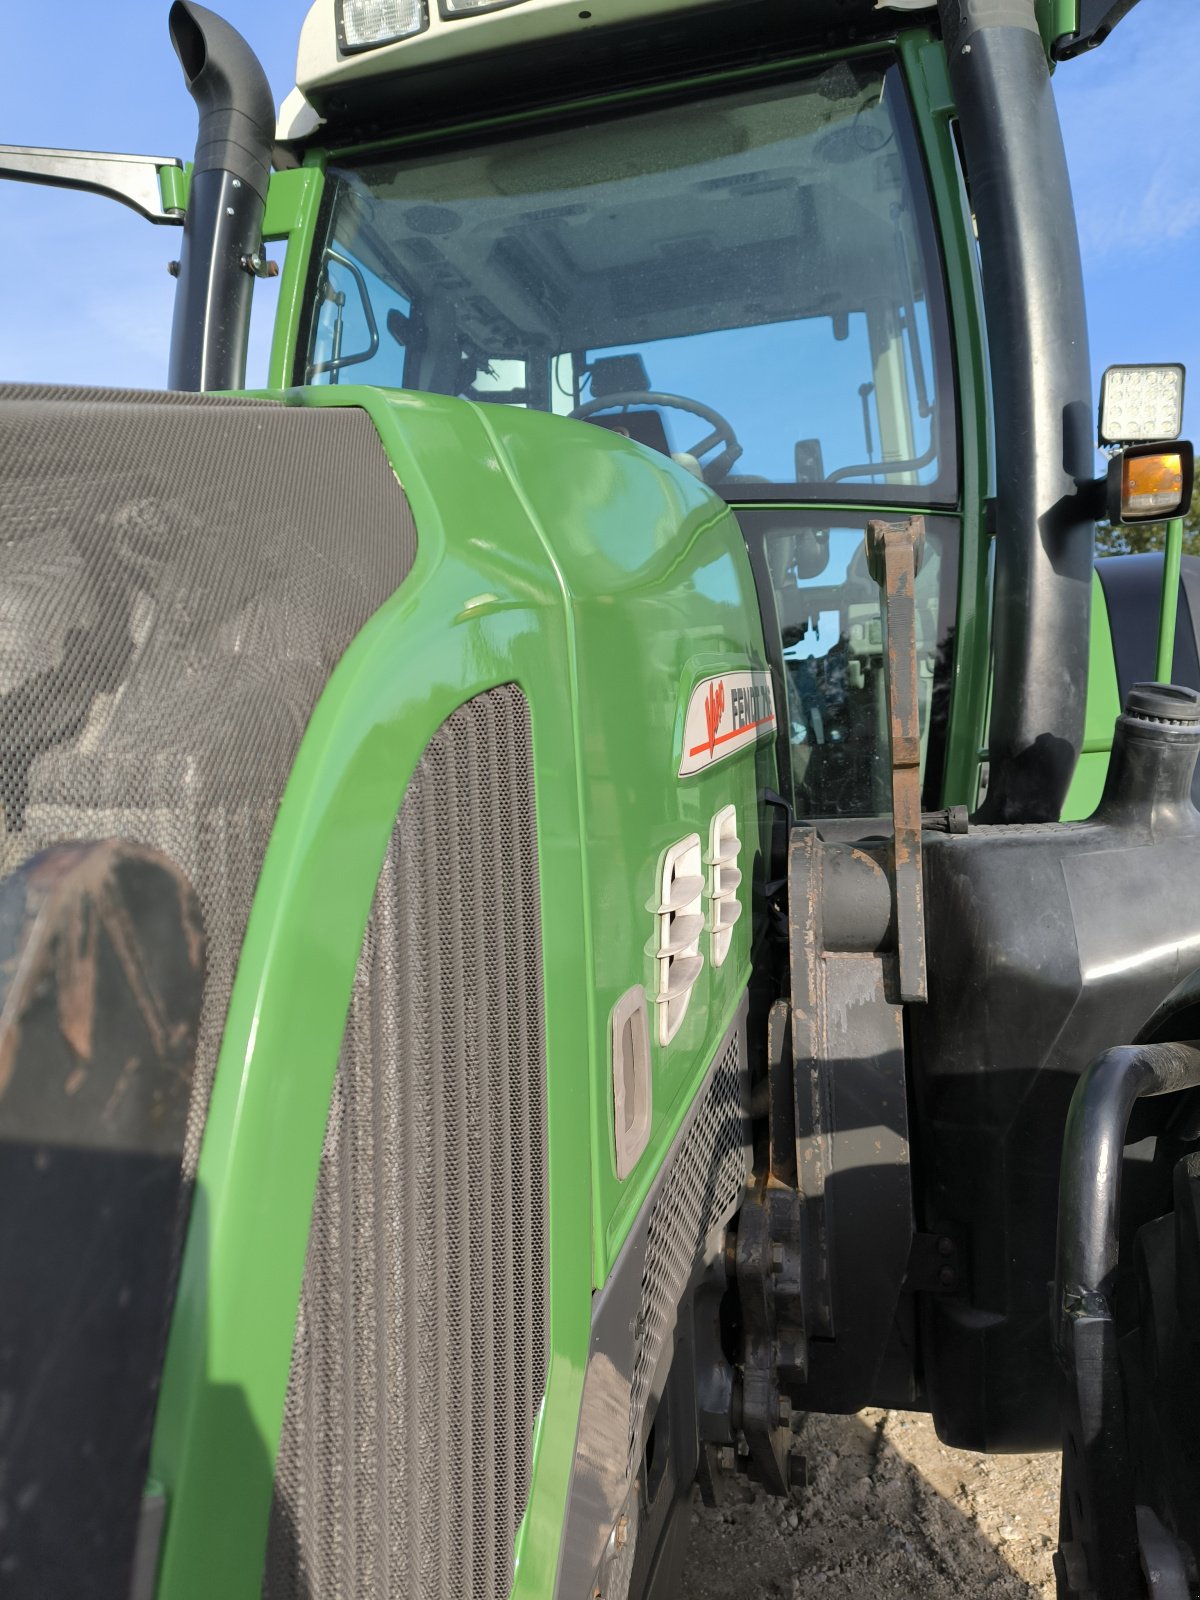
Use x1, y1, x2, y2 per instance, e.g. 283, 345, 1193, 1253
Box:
629, 1027, 749, 1475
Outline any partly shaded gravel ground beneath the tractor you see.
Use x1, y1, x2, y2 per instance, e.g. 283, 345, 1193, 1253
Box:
682, 1411, 1059, 1600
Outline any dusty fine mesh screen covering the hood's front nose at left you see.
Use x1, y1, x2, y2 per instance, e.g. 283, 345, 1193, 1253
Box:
0, 386, 414, 1170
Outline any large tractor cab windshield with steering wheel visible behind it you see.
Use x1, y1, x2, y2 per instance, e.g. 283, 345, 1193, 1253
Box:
304, 61, 955, 504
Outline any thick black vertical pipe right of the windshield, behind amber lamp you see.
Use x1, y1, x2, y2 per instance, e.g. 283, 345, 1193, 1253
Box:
938, 0, 1094, 822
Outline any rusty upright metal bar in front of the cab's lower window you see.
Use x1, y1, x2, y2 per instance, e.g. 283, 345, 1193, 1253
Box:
867, 517, 930, 1000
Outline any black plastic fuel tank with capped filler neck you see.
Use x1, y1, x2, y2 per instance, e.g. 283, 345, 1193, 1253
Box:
909, 685, 1200, 1451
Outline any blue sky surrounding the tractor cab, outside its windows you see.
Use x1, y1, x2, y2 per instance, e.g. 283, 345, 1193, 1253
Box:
0, 0, 1200, 451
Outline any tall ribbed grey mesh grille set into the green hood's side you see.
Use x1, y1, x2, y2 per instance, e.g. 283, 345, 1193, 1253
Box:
262, 685, 549, 1600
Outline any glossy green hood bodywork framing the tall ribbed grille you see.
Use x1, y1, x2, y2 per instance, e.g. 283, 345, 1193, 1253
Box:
150, 386, 770, 1600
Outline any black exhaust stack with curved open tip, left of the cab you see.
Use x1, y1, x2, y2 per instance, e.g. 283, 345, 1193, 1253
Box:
166, 0, 275, 390
